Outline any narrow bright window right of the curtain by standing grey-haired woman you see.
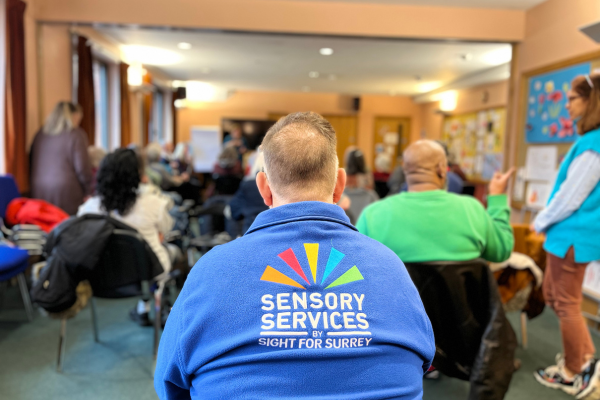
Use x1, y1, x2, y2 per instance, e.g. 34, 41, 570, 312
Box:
93, 60, 110, 151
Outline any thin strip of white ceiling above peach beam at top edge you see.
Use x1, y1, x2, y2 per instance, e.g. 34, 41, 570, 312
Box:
274, 0, 546, 10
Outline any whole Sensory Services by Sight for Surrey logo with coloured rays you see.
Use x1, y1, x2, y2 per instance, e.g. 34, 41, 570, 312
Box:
258, 243, 372, 349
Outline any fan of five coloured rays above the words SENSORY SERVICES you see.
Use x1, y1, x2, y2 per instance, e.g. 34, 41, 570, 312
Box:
260, 243, 364, 290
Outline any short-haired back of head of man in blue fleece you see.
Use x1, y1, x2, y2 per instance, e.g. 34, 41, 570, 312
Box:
261, 112, 338, 202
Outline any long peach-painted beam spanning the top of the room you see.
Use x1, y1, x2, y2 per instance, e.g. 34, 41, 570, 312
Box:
39, 0, 525, 42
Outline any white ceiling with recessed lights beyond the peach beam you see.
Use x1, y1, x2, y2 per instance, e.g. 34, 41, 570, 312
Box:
98, 27, 510, 95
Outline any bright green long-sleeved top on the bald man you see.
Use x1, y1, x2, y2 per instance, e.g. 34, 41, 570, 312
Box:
356, 190, 514, 262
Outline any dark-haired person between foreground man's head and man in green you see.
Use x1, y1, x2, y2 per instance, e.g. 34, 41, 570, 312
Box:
344, 147, 379, 219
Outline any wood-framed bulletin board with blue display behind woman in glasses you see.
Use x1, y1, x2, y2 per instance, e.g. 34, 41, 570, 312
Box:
512, 52, 600, 209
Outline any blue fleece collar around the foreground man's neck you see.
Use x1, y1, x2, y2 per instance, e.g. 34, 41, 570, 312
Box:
246, 201, 357, 235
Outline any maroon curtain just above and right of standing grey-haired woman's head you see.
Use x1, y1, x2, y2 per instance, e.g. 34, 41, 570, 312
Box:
77, 36, 96, 145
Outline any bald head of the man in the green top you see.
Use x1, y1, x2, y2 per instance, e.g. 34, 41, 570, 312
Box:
404, 140, 448, 191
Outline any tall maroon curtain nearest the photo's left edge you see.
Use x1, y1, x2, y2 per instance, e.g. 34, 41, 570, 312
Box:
5, 0, 29, 193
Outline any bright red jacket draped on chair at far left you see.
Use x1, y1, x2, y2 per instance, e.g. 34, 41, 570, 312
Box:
6, 197, 69, 232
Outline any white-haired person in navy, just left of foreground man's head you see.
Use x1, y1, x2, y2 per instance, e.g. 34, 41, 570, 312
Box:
229, 152, 269, 234
